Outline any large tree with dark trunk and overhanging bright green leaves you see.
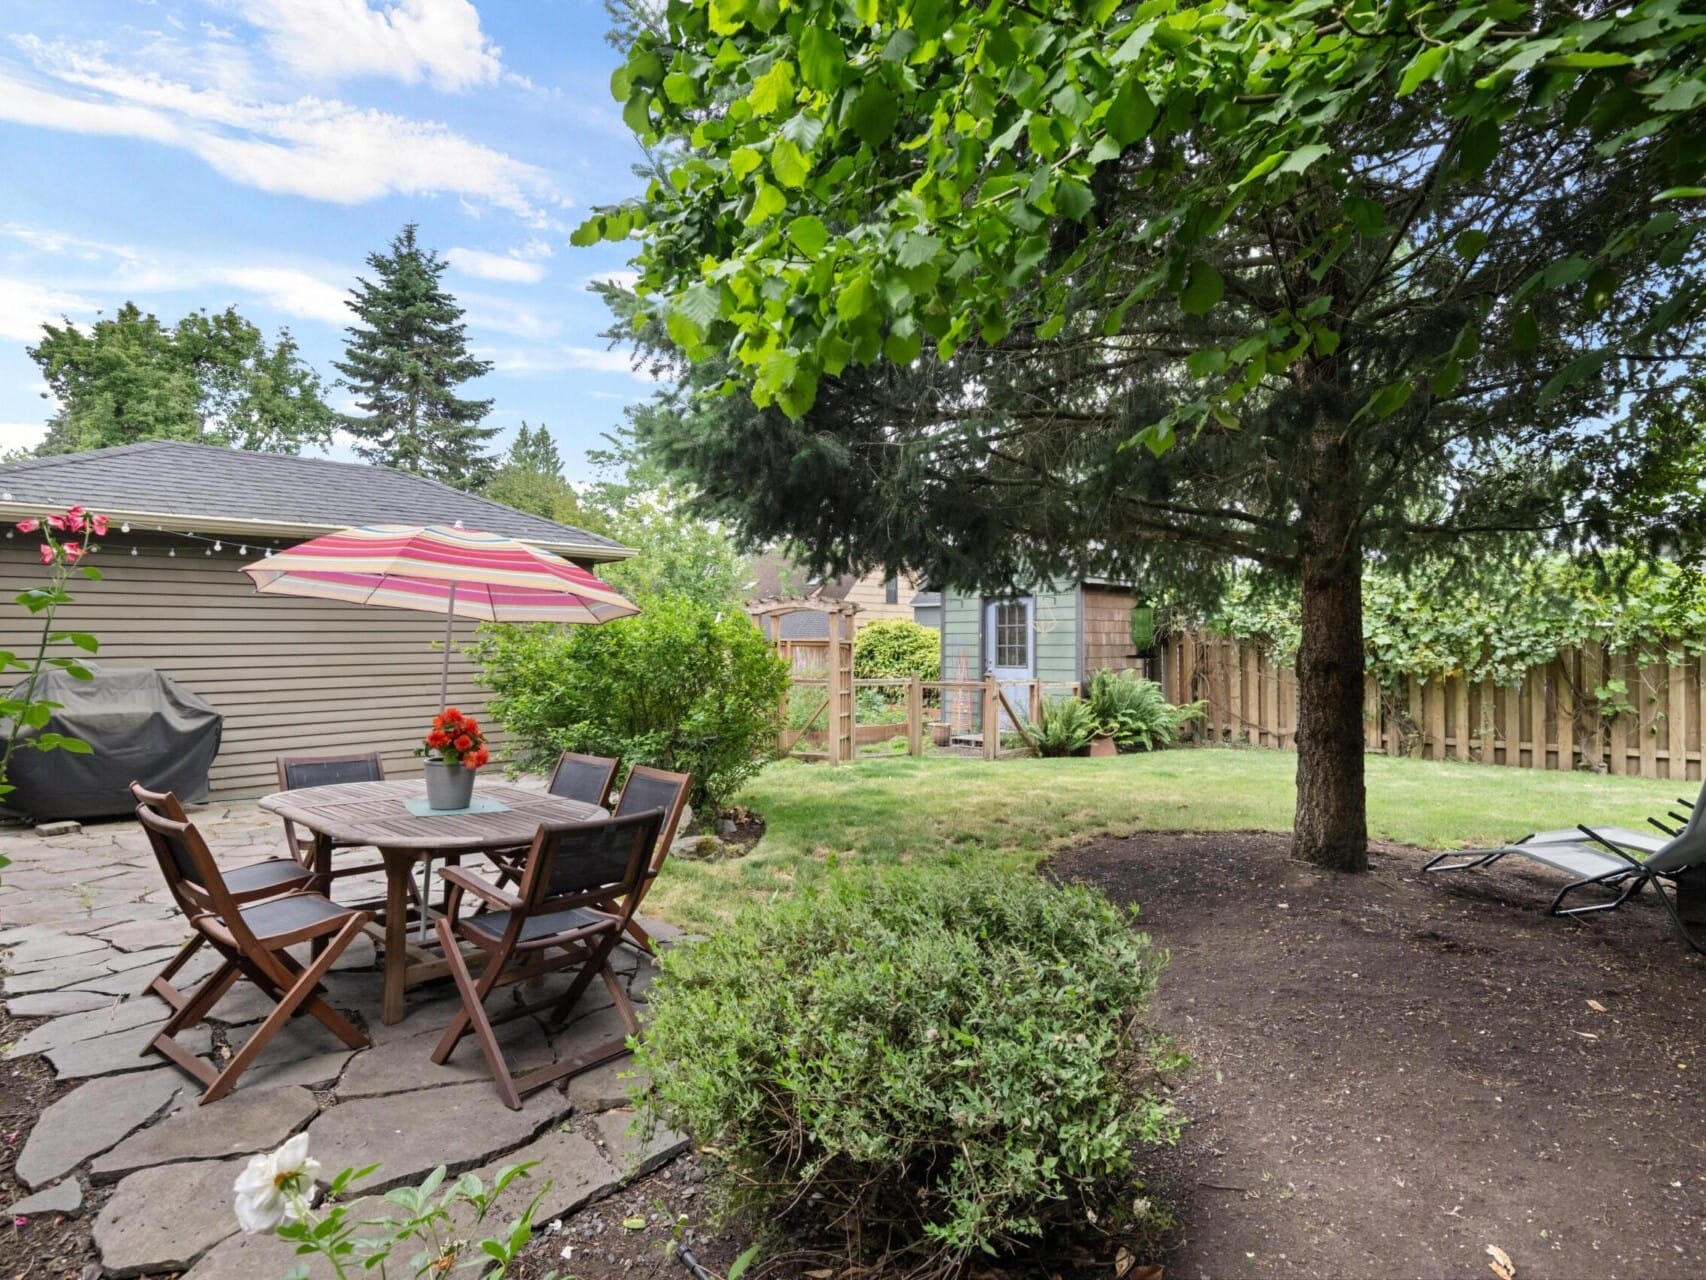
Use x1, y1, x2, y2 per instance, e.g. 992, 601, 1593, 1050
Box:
578, 0, 1706, 867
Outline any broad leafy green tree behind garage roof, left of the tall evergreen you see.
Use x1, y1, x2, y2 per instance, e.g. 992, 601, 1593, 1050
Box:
29, 302, 336, 454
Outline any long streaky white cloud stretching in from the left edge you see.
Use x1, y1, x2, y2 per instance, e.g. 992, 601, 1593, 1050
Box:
0, 36, 563, 225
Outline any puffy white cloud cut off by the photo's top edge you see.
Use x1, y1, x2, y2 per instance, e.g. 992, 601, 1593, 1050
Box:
239, 0, 503, 89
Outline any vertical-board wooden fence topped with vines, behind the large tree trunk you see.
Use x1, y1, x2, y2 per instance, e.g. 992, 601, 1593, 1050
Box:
1160, 633, 1706, 782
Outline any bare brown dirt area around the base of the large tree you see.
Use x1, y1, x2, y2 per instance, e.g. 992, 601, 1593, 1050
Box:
1047, 831, 1706, 1280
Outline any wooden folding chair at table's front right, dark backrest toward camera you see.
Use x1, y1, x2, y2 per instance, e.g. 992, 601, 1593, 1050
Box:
432, 809, 664, 1111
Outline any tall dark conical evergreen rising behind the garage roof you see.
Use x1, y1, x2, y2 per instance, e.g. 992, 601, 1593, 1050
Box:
336, 222, 498, 488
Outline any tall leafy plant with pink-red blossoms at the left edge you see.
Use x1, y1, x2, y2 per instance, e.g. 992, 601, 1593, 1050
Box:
0, 507, 107, 887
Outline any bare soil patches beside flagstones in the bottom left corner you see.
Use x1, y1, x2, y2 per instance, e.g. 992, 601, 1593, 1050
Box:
0, 1007, 96, 1280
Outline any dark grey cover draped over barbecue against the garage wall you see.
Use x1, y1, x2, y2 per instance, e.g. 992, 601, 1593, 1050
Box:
0, 662, 223, 823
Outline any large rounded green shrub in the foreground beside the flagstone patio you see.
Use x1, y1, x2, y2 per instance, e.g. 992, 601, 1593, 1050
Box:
636, 865, 1179, 1275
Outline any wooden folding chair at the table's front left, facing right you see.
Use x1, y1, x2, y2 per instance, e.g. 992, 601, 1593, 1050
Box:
136, 804, 372, 1104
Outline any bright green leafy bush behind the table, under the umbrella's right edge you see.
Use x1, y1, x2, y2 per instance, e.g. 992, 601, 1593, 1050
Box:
474, 597, 788, 816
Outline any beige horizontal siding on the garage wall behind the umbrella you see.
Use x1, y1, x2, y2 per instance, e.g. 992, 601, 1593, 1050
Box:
0, 532, 496, 797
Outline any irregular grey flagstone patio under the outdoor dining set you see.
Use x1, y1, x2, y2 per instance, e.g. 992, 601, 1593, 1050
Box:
0, 802, 686, 1280
